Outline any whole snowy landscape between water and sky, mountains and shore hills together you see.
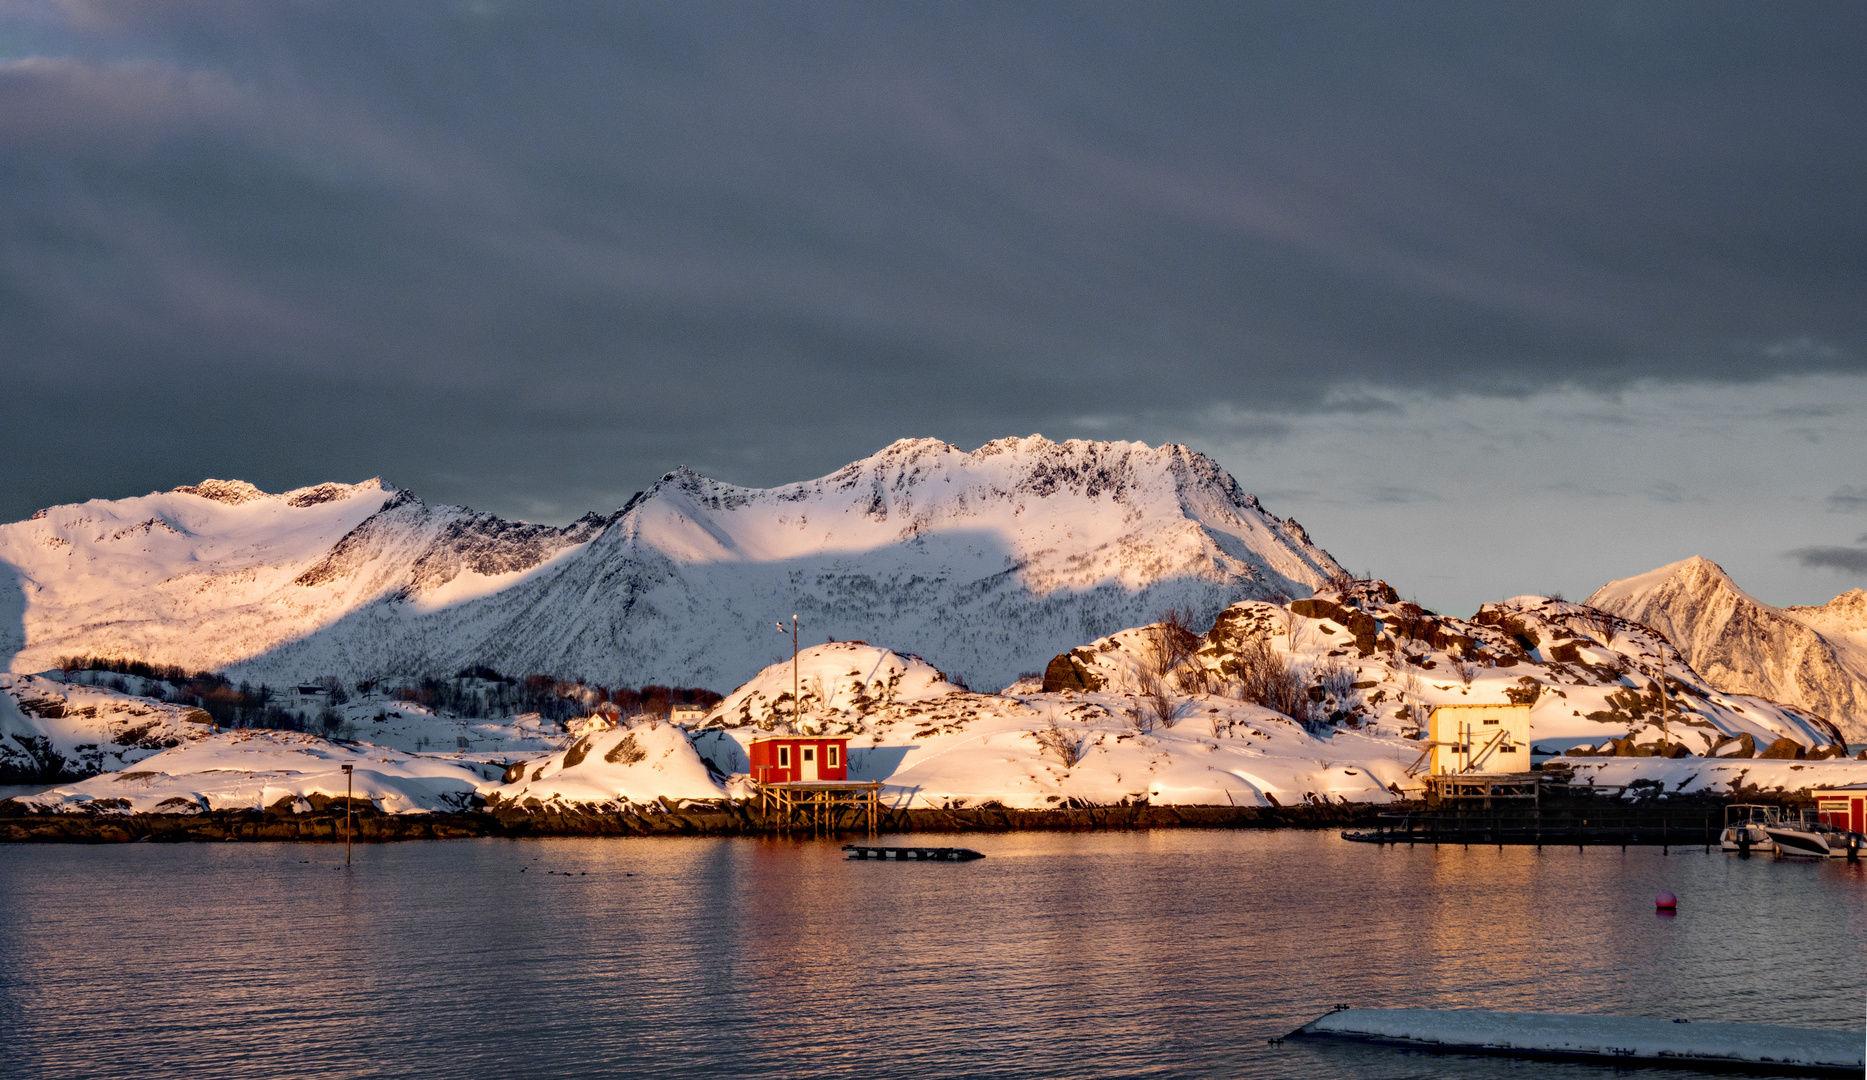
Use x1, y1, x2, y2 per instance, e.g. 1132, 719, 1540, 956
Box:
0, 435, 1867, 833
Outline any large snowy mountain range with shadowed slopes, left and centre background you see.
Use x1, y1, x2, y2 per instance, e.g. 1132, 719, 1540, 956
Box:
0, 435, 1341, 686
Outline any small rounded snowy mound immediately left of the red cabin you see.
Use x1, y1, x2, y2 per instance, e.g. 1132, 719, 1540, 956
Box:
485, 718, 726, 805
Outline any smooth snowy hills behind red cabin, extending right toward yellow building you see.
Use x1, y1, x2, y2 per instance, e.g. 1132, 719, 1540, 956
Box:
695, 643, 1417, 809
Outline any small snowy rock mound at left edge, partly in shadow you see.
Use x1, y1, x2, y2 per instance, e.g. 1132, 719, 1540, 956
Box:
0, 673, 215, 781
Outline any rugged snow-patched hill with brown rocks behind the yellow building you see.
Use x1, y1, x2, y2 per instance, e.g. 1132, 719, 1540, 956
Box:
1046, 581, 1837, 757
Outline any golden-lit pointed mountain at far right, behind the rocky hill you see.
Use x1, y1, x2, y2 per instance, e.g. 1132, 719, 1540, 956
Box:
1587, 557, 1867, 742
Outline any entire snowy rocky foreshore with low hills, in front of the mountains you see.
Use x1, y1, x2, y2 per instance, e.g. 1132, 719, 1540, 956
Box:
0, 581, 1867, 833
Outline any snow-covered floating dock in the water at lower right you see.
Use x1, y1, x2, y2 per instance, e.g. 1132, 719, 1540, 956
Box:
1292, 1009, 1867, 1076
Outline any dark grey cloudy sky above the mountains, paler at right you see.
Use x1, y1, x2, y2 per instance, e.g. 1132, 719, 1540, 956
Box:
0, 0, 1867, 613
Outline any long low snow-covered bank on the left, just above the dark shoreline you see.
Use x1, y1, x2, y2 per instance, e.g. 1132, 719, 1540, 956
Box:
13, 731, 498, 815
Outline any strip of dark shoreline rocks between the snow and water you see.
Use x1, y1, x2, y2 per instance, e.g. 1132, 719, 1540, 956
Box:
0, 800, 1393, 843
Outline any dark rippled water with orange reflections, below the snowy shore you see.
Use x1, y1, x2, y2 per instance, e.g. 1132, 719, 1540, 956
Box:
0, 831, 1867, 1078
